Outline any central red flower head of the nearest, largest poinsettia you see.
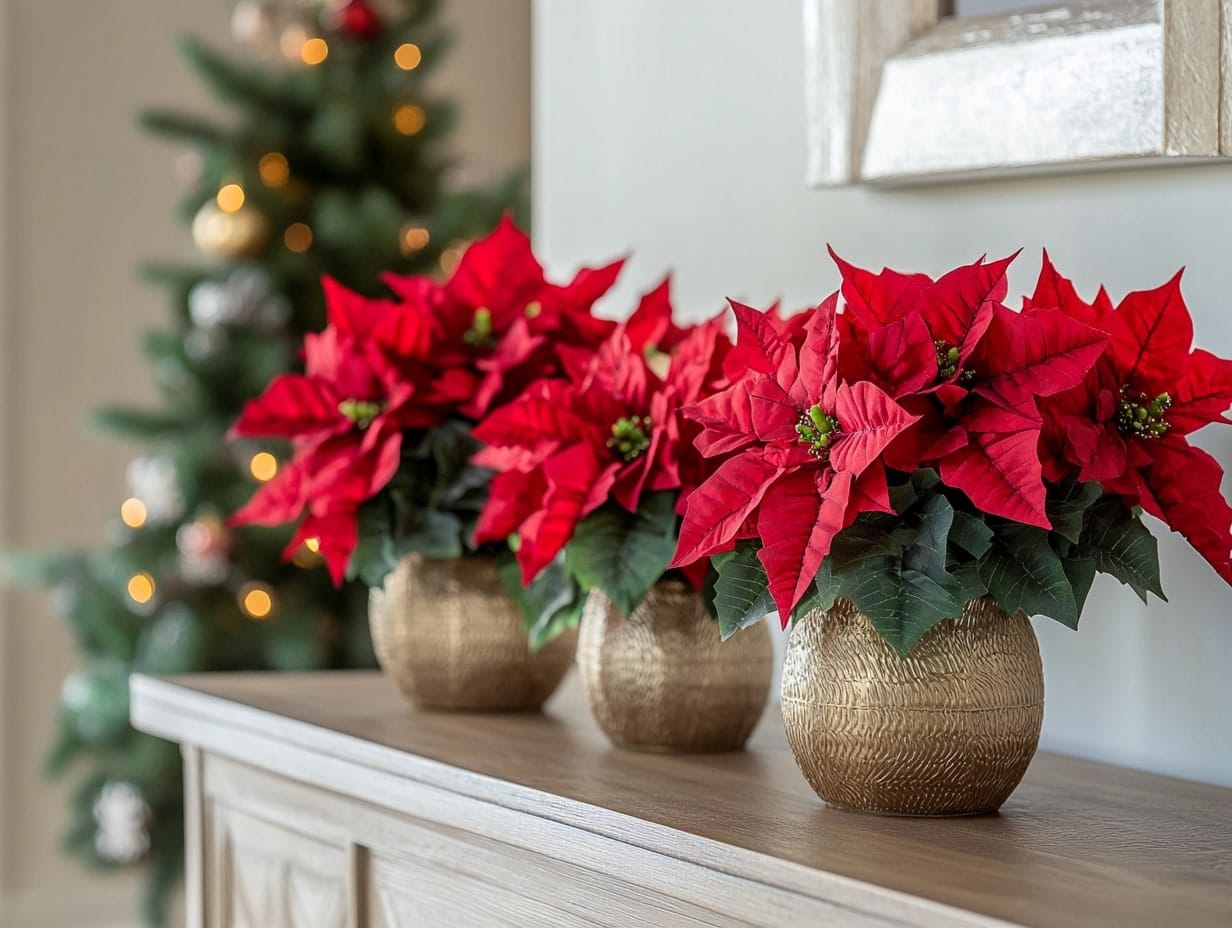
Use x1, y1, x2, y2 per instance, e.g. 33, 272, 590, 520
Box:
835, 250, 1108, 529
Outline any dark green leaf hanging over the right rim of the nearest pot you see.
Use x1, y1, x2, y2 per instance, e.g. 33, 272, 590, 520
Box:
979, 524, 1078, 629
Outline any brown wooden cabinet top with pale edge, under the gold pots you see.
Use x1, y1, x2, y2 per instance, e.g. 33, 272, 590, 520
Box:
133, 673, 1232, 928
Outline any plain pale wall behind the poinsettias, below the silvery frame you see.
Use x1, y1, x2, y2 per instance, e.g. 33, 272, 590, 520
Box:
533, 0, 1232, 785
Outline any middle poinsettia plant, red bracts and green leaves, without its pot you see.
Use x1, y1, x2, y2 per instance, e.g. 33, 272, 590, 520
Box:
474, 281, 731, 646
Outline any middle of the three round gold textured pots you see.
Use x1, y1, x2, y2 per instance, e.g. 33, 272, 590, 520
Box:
578, 580, 774, 753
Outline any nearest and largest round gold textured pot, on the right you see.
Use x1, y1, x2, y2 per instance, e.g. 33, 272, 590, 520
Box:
782, 596, 1044, 816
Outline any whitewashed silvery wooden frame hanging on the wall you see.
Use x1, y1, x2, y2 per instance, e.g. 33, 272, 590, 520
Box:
803, 0, 1232, 186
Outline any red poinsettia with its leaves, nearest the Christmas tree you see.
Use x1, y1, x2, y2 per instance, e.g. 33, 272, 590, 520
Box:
233, 219, 621, 585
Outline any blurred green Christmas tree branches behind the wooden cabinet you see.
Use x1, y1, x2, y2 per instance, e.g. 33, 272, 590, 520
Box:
22, 0, 524, 926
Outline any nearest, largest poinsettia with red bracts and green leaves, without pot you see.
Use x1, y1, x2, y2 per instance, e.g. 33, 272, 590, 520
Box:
673, 250, 1232, 656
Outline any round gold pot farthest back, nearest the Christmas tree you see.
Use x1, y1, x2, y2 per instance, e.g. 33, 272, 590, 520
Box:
368, 555, 578, 711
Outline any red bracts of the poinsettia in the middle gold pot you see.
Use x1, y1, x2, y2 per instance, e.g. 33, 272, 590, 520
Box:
474, 283, 729, 583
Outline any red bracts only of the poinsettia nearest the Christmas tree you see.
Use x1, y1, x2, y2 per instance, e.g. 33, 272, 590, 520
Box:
233, 218, 621, 583
